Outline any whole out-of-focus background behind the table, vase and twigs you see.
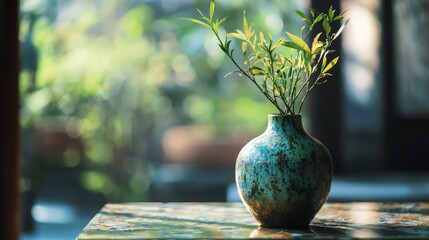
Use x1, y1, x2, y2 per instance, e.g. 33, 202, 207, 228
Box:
20, 0, 429, 240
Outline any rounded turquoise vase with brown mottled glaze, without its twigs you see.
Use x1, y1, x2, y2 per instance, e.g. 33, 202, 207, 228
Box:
235, 115, 332, 229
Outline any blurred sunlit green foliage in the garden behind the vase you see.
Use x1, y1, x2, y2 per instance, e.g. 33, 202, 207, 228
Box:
20, 0, 303, 201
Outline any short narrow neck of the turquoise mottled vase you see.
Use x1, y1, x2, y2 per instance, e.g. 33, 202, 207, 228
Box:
267, 114, 305, 134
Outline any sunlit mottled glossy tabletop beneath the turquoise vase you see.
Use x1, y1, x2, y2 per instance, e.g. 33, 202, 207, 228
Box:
78, 202, 429, 239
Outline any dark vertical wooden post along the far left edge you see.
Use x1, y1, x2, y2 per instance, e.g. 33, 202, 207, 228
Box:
0, 0, 19, 240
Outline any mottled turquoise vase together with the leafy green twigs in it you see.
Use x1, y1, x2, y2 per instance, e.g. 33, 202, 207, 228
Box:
185, 0, 348, 228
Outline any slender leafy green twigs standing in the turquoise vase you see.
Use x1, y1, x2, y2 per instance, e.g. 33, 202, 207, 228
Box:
184, 0, 349, 115
